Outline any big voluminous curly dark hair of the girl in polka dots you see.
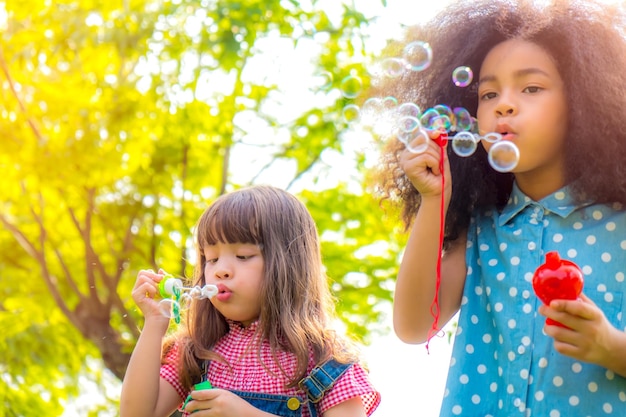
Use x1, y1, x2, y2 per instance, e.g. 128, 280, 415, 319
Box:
372, 0, 626, 245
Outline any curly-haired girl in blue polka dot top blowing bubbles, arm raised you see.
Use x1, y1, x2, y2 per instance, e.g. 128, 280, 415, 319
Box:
380, 0, 626, 417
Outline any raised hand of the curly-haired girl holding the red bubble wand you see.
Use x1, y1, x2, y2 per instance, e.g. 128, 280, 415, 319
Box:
399, 131, 451, 198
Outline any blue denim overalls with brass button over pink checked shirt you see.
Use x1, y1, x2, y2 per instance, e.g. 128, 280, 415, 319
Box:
202, 359, 352, 417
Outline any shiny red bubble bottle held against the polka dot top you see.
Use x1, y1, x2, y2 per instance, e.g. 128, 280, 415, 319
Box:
533, 251, 583, 327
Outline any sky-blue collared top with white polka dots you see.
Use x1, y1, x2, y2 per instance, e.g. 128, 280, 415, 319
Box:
441, 186, 626, 417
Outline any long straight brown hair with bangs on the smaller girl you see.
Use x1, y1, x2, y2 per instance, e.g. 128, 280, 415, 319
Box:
164, 185, 356, 388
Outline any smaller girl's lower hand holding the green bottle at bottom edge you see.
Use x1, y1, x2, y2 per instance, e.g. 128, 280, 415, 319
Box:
184, 388, 271, 417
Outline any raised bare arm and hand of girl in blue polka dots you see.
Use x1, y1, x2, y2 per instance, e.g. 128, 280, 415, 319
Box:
393, 136, 467, 343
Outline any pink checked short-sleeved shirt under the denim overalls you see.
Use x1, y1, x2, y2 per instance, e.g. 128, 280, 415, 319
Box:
160, 322, 380, 417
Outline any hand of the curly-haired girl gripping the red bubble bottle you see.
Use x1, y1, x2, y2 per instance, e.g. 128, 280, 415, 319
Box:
539, 294, 626, 375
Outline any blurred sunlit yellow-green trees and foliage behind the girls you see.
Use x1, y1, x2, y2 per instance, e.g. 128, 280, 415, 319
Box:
0, 0, 403, 416
